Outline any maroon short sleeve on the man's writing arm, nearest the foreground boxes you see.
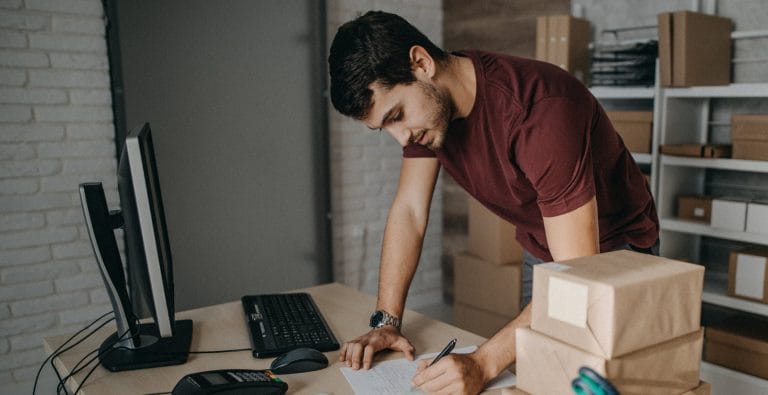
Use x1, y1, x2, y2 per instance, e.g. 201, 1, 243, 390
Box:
512, 97, 595, 217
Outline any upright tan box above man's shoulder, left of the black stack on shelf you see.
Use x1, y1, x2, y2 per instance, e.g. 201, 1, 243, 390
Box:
536, 15, 592, 82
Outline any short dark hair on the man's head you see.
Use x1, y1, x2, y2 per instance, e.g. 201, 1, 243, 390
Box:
328, 11, 448, 119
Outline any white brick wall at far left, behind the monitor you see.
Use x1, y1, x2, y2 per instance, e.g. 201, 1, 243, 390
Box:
0, 0, 117, 394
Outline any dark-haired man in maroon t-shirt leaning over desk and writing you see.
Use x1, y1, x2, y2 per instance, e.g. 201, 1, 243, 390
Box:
328, 12, 658, 393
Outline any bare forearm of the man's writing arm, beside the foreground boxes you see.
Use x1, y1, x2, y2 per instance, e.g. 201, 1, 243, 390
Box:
476, 304, 531, 380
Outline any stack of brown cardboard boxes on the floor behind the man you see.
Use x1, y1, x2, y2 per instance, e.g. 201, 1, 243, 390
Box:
453, 198, 523, 337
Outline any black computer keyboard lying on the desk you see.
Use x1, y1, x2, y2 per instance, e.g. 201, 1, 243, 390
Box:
242, 293, 339, 358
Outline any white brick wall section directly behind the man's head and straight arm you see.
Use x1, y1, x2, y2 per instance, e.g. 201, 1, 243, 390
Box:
326, 0, 443, 308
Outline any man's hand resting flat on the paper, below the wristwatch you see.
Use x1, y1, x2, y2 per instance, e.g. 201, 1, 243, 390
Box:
339, 325, 414, 370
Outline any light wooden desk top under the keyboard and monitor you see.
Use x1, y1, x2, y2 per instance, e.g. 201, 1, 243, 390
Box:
45, 284, 510, 395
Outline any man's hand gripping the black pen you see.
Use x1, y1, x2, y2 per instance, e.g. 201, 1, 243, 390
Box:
411, 353, 485, 394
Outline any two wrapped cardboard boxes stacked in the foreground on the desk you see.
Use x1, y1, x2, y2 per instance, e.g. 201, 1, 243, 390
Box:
516, 251, 704, 394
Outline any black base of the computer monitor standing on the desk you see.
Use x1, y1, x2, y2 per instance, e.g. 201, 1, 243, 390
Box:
99, 320, 192, 372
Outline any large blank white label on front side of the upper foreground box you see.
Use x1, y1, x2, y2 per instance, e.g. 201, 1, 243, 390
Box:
547, 277, 589, 328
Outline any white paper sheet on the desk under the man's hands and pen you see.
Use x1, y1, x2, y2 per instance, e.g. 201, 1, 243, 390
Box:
341, 346, 517, 394
